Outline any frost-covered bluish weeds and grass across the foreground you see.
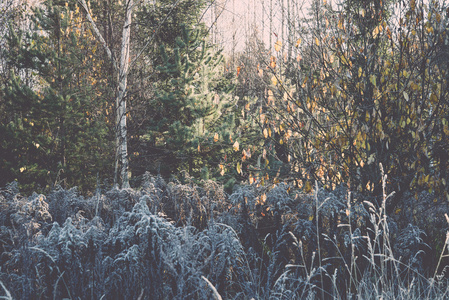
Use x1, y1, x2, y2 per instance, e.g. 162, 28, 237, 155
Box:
0, 175, 449, 299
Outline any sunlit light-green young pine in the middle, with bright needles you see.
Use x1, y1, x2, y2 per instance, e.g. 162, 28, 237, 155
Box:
145, 26, 234, 177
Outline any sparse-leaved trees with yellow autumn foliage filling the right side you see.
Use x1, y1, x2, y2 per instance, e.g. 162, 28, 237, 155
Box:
247, 1, 449, 205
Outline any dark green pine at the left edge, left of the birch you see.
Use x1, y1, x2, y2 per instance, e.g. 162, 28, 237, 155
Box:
0, 1, 111, 190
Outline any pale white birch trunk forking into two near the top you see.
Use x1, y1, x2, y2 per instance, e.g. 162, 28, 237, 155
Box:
78, 0, 134, 188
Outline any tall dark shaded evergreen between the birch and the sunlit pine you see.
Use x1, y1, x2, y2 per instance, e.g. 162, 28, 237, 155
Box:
127, 0, 207, 180
